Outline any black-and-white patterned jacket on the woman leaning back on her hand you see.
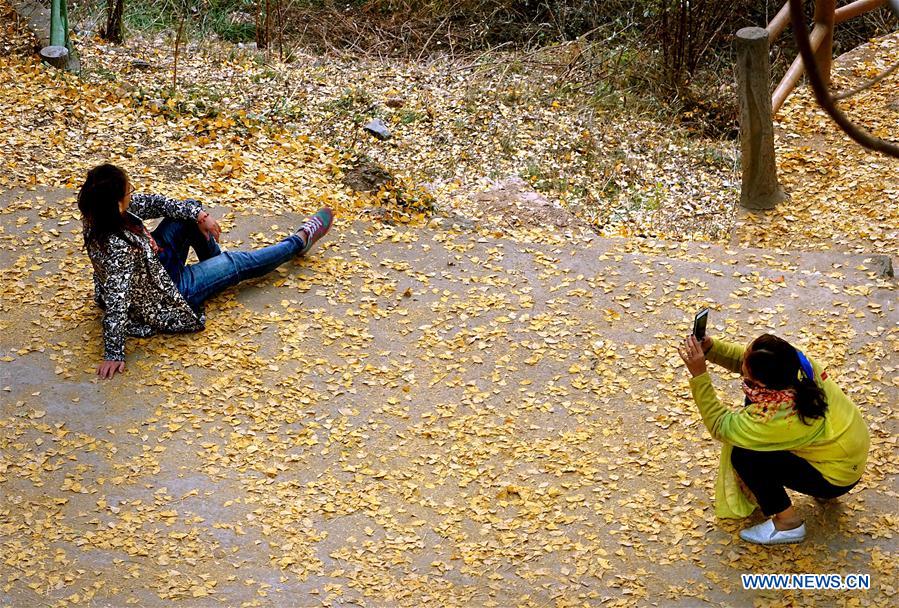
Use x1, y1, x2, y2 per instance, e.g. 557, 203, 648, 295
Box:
87, 194, 206, 361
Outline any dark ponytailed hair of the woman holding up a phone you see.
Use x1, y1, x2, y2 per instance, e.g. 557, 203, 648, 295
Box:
746, 334, 827, 424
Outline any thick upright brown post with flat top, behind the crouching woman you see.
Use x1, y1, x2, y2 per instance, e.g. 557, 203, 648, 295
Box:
734, 27, 787, 209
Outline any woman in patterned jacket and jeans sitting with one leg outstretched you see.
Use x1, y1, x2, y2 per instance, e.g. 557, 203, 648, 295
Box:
78, 164, 333, 378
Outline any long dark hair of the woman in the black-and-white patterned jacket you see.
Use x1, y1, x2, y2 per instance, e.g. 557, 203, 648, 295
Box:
78, 164, 132, 246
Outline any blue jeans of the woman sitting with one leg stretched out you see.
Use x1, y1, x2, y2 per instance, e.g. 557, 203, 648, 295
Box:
153, 218, 303, 311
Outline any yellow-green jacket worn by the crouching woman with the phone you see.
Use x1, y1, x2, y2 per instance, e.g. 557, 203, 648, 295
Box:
690, 340, 870, 518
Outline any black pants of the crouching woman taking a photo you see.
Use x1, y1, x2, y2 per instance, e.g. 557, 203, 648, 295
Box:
730, 446, 858, 515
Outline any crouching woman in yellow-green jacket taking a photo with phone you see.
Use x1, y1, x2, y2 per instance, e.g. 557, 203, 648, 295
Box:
680, 334, 870, 545
